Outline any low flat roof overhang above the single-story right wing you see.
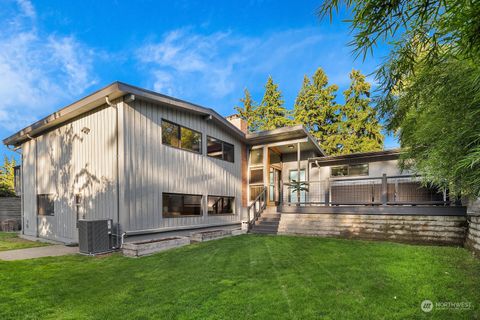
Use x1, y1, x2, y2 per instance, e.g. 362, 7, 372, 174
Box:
309, 149, 402, 167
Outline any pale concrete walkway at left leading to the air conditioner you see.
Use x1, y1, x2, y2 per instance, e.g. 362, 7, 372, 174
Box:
0, 245, 78, 261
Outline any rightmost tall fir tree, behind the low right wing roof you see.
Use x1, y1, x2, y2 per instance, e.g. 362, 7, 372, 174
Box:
333, 70, 383, 154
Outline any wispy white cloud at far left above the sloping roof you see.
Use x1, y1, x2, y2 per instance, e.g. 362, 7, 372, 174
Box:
0, 0, 95, 131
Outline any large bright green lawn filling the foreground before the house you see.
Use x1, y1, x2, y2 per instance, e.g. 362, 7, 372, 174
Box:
0, 235, 480, 319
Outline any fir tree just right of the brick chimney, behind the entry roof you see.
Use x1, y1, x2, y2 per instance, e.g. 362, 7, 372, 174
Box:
257, 76, 291, 131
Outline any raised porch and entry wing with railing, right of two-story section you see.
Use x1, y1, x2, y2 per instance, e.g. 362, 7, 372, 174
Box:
244, 127, 466, 222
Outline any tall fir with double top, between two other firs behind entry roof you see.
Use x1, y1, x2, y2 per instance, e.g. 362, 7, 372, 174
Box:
293, 68, 339, 154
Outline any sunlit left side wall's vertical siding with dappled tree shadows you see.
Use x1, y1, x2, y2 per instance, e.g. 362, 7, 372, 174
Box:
23, 108, 117, 242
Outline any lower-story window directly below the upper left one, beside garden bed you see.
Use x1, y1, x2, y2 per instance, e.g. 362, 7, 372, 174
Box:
162, 193, 202, 218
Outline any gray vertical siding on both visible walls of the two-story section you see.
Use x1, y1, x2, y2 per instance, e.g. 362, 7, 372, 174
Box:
22, 99, 242, 242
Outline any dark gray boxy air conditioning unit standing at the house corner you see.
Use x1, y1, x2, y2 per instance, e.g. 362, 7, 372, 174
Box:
78, 220, 112, 254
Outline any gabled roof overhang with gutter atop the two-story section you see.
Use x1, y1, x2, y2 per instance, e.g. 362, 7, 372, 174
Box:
3, 81, 246, 147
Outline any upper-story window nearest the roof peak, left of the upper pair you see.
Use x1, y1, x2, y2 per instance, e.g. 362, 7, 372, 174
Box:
162, 119, 202, 153
